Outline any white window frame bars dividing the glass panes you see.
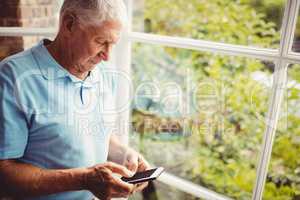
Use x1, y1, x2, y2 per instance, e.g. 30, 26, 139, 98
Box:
0, 0, 300, 200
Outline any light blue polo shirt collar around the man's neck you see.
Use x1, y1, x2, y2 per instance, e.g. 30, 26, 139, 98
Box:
32, 39, 101, 87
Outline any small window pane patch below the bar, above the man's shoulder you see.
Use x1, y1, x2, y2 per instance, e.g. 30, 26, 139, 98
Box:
0, 36, 48, 61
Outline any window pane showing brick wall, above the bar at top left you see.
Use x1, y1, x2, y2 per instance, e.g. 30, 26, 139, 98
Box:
0, 0, 63, 28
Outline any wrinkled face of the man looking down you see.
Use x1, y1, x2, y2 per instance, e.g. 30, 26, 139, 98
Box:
69, 21, 121, 72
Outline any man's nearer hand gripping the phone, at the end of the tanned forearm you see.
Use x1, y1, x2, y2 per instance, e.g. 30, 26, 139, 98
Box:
85, 162, 135, 200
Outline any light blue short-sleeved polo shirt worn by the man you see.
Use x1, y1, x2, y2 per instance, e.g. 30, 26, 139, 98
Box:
0, 40, 115, 200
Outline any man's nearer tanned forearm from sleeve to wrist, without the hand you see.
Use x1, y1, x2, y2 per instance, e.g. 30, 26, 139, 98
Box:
0, 160, 88, 197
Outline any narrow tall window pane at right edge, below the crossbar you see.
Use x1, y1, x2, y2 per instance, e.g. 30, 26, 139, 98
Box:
264, 65, 300, 200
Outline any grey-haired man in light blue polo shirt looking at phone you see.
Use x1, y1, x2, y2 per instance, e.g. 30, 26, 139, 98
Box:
0, 0, 149, 200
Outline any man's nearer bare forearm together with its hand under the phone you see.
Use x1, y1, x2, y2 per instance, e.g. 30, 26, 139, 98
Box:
0, 160, 134, 199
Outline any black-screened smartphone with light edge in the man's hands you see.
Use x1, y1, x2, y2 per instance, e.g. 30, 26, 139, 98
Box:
121, 167, 164, 184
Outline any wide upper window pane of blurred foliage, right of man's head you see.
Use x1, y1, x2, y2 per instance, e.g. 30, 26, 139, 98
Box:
133, 0, 286, 48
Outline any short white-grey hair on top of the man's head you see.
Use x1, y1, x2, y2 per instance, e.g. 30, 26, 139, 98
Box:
60, 0, 127, 26
